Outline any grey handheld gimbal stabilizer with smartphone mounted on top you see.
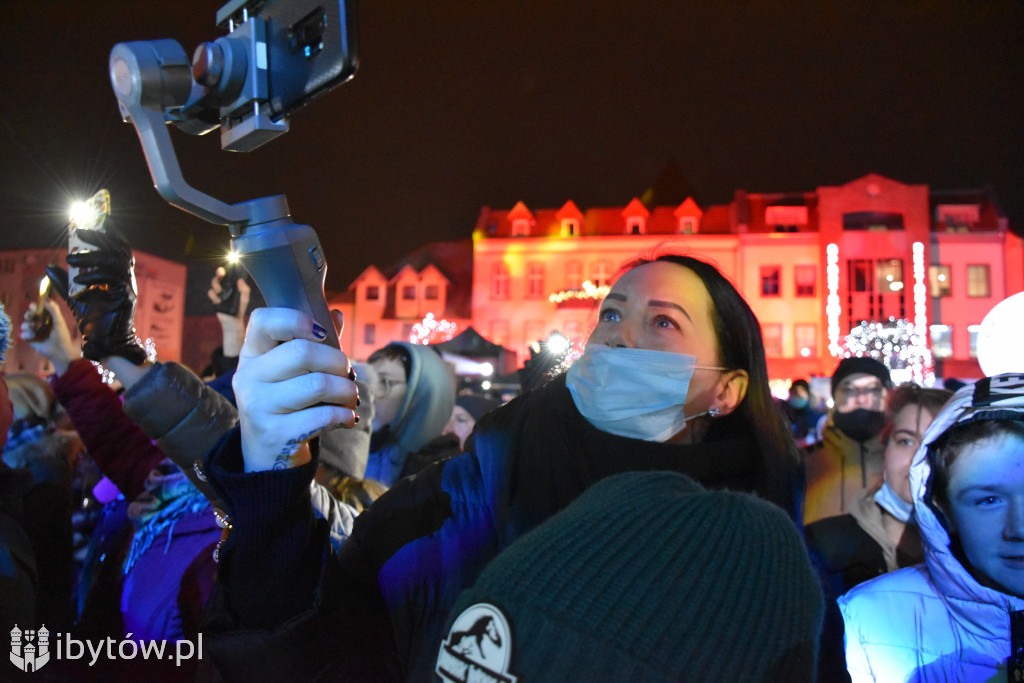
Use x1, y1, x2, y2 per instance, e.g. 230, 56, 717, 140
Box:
110, 0, 356, 346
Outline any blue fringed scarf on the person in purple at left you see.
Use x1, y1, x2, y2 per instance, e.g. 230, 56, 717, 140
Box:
124, 460, 209, 574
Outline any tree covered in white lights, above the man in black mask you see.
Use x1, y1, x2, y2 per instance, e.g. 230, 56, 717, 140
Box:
840, 317, 935, 387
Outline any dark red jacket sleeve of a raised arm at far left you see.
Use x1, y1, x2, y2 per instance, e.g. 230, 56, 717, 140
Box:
52, 358, 164, 501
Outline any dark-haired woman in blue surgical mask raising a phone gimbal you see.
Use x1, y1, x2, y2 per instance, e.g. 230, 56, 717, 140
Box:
192, 248, 802, 681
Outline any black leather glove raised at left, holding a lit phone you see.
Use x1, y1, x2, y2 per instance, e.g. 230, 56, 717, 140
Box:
46, 226, 145, 366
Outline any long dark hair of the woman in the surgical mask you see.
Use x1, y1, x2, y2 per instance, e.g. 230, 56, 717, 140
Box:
620, 245, 801, 513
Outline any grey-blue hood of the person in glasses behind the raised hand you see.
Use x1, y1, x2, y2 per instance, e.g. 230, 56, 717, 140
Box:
365, 342, 456, 486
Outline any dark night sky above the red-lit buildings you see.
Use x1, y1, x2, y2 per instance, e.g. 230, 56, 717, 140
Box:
0, 0, 1024, 312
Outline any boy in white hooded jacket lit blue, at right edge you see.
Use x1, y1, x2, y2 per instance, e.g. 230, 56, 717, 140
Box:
839, 375, 1024, 681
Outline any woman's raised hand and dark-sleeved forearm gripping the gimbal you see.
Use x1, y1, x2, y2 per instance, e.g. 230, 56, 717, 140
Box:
204, 308, 358, 629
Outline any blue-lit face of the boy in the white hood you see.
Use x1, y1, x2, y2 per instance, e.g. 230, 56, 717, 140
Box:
947, 434, 1024, 597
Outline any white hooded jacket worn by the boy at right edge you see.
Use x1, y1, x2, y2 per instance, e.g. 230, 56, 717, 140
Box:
839, 375, 1024, 681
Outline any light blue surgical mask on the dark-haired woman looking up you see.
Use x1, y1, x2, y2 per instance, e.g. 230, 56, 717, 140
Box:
565, 344, 725, 441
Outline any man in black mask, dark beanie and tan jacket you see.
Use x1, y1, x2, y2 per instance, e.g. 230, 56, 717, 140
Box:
804, 357, 892, 523
